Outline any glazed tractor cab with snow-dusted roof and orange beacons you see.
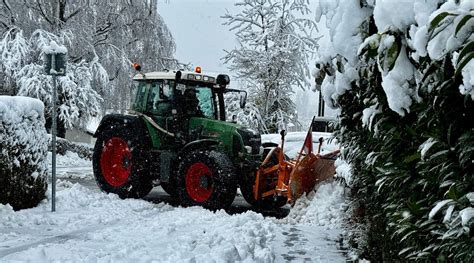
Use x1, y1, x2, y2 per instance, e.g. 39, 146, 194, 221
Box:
131, 69, 246, 121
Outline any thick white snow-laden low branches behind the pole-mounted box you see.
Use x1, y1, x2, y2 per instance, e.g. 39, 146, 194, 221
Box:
0, 29, 103, 131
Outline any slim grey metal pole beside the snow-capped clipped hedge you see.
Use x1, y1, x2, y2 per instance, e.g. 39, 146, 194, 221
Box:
51, 59, 57, 212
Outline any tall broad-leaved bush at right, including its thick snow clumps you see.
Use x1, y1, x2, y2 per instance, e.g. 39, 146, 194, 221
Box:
315, 0, 474, 262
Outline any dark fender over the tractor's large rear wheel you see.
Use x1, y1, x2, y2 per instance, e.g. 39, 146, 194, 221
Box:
94, 114, 147, 138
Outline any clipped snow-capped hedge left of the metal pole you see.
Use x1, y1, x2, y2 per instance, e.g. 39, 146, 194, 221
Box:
0, 96, 48, 210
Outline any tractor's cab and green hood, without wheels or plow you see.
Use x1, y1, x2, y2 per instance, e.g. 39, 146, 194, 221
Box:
131, 67, 252, 156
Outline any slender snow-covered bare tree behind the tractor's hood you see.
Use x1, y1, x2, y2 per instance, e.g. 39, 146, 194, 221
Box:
223, 0, 316, 132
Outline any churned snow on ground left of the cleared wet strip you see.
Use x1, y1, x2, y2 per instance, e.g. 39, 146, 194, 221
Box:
0, 183, 275, 262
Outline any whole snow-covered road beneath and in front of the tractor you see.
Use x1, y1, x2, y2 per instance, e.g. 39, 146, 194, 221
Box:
0, 135, 346, 262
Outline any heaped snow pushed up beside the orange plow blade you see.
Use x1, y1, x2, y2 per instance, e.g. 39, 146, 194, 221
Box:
282, 181, 346, 229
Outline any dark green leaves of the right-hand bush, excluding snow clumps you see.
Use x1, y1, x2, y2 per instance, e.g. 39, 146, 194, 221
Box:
326, 3, 474, 262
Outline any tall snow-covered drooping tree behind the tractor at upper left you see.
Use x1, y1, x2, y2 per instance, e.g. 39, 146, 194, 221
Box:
0, 0, 177, 136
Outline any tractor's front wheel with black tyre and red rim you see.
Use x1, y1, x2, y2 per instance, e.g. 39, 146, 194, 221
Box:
177, 150, 237, 210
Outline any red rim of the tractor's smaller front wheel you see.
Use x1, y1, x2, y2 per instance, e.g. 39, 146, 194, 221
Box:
186, 162, 214, 203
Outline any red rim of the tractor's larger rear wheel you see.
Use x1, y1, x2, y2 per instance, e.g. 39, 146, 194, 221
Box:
100, 137, 132, 187
